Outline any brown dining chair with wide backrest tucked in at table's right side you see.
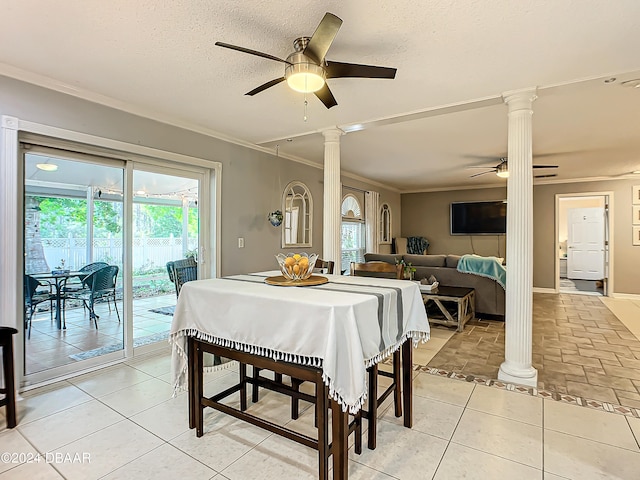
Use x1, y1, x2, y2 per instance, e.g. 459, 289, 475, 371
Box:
351, 262, 400, 450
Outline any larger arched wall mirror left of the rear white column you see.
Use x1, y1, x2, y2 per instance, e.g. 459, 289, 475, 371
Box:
282, 181, 313, 248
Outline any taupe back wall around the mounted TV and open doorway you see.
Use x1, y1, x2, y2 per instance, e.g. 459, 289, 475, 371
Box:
402, 179, 640, 294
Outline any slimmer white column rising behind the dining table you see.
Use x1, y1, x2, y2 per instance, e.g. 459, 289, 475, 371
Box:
322, 128, 344, 266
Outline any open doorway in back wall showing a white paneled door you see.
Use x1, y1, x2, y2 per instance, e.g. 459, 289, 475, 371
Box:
556, 192, 611, 296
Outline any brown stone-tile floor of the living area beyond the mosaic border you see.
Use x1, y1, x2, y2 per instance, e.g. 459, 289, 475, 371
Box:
428, 293, 640, 408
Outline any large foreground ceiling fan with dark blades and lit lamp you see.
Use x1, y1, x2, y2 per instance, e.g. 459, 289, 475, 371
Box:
216, 12, 396, 108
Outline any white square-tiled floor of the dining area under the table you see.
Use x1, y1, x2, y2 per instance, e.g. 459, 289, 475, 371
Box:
0, 329, 640, 480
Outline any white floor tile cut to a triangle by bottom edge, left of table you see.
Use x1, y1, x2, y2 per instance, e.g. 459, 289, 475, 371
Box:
103, 443, 217, 480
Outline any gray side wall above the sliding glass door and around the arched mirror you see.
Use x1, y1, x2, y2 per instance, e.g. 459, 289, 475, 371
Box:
0, 76, 400, 275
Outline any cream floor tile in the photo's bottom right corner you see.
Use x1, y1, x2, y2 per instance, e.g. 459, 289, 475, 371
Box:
544, 430, 640, 480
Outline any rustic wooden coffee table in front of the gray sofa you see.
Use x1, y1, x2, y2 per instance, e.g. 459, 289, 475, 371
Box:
422, 285, 476, 332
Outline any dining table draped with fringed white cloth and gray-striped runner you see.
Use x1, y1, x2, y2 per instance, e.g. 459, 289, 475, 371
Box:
169, 271, 430, 479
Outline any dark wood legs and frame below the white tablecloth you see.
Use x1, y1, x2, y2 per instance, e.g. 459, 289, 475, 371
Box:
187, 337, 413, 480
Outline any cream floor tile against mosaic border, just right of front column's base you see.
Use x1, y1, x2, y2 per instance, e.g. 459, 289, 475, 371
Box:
544, 400, 640, 452
